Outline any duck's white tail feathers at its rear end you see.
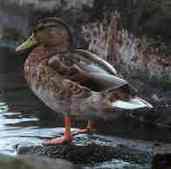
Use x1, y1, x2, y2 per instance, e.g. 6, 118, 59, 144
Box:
112, 97, 153, 110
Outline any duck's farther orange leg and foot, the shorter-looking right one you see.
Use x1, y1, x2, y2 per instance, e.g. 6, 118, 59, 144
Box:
73, 120, 96, 135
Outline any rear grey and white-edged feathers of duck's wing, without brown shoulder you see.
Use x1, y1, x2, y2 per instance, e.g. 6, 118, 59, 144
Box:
73, 49, 128, 91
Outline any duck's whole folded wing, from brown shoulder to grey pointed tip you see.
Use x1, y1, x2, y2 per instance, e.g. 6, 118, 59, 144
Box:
49, 49, 128, 91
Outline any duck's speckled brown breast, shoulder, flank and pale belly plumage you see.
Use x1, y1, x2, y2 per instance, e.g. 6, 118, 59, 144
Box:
24, 46, 117, 116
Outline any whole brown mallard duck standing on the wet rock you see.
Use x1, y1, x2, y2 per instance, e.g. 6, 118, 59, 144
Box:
16, 18, 152, 144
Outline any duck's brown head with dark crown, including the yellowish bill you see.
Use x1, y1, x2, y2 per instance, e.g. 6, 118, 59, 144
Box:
16, 17, 73, 52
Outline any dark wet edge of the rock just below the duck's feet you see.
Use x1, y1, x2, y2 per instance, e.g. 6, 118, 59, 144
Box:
17, 143, 152, 164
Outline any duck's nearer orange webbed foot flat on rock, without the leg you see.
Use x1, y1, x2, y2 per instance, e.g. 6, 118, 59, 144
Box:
44, 137, 73, 145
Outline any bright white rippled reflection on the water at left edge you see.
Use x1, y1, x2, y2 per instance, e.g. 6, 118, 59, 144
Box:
0, 103, 56, 155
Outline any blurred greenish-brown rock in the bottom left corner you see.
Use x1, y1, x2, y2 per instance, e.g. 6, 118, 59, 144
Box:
0, 155, 79, 169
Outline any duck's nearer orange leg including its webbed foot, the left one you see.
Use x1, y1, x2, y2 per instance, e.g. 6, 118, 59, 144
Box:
45, 116, 73, 144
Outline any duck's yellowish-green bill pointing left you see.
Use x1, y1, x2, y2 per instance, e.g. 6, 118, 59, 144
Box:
16, 34, 37, 52
